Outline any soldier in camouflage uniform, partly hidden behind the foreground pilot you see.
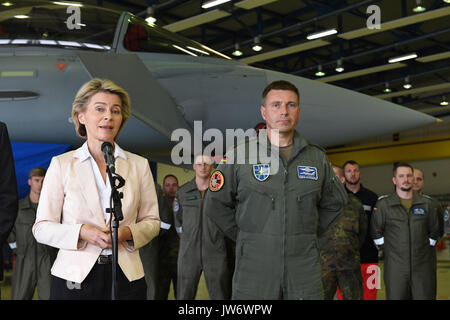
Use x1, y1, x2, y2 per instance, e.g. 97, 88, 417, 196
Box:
319, 166, 367, 300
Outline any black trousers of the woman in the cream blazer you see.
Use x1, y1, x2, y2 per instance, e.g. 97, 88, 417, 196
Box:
50, 263, 147, 300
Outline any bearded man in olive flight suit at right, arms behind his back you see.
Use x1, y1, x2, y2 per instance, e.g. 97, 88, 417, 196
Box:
371, 163, 442, 300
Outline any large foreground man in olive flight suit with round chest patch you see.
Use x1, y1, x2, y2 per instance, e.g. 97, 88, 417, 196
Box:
205, 81, 348, 300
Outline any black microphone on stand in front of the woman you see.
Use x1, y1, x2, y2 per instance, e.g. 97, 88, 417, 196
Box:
106, 165, 125, 300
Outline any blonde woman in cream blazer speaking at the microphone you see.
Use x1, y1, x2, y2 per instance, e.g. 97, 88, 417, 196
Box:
33, 79, 160, 299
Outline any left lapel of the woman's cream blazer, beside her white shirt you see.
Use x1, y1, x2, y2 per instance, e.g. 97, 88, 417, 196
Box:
75, 154, 106, 226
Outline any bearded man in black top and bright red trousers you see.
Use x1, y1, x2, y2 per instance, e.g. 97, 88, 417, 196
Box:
343, 160, 378, 300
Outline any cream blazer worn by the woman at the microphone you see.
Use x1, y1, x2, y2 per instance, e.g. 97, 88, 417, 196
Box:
33, 148, 160, 283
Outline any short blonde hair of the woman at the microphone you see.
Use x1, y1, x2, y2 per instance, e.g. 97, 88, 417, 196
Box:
72, 78, 131, 140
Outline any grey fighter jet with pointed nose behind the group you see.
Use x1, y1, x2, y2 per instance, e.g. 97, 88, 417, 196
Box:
0, 1, 436, 163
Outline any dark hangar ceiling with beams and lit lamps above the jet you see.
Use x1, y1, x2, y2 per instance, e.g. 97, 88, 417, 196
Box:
24, 0, 450, 117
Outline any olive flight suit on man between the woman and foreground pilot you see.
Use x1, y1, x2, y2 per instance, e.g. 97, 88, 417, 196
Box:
173, 178, 231, 300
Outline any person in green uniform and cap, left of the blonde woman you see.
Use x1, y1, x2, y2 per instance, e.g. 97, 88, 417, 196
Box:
8, 168, 57, 300
